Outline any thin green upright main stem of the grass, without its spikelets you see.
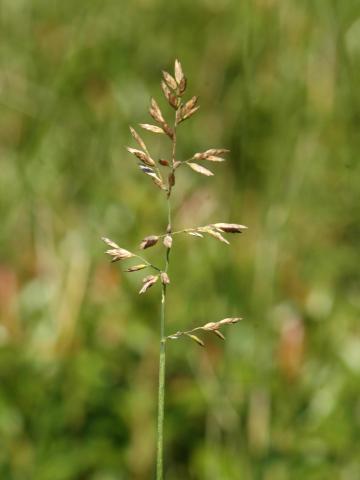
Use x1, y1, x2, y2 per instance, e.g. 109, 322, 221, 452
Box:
156, 111, 176, 480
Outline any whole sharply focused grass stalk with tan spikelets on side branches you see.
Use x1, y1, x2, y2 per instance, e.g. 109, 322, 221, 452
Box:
103, 60, 247, 480
